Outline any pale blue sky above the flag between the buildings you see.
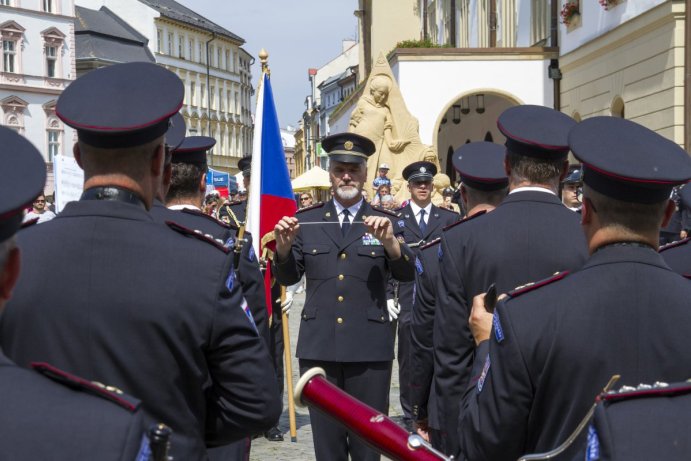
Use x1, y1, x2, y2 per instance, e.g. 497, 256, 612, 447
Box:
177, 0, 358, 128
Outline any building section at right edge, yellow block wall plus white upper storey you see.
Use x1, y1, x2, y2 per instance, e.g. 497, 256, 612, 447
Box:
559, 0, 691, 150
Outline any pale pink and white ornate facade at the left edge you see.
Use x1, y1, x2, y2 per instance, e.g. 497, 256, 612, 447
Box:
0, 0, 76, 190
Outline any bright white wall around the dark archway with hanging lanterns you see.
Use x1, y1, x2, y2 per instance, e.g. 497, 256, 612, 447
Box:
392, 60, 554, 144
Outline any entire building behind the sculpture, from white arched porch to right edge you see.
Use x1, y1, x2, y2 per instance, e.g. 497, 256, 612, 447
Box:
329, 0, 691, 183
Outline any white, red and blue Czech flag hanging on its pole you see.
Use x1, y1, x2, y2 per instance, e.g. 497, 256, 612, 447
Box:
246, 72, 297, 316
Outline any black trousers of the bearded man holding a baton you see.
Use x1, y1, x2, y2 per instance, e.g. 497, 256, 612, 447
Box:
300, 359, 392, 461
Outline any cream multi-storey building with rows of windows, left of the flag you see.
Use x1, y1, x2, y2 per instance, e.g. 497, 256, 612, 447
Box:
77, 0, 254, 174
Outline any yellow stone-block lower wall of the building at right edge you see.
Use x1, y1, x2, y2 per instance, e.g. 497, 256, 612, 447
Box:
560, 2, 684, 146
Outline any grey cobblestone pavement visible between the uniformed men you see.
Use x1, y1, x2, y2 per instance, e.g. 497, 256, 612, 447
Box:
250, 294, 402, 461
